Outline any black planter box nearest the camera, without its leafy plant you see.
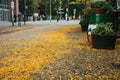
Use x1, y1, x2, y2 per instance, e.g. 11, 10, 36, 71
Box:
92, 35, 116, 49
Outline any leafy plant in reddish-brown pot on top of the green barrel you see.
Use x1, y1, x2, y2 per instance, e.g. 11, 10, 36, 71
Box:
91, 1, 113, 14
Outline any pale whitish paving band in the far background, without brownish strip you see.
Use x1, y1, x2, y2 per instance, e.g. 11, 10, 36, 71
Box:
0, 20, 79, 28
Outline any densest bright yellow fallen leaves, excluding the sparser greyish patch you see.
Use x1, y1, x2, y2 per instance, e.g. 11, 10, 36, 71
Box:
0, 26, 120, 80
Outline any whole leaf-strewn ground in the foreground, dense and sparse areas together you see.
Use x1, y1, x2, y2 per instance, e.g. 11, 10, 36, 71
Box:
0, 25, 120, 80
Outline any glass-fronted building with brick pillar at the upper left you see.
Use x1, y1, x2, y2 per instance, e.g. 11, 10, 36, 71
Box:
0, 0, 19, 21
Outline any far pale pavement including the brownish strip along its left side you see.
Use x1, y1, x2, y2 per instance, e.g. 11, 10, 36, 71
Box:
0, 20, 79, 35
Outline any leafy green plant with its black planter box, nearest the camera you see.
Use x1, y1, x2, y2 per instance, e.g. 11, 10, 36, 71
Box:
91, 23, 116, 49
